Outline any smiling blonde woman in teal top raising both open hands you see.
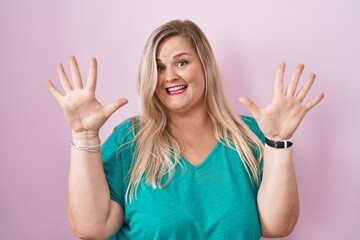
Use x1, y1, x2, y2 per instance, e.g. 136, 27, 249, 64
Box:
47, 21, 324, 240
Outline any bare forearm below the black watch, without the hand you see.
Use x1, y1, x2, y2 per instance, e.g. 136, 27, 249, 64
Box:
257, 146, 299, 237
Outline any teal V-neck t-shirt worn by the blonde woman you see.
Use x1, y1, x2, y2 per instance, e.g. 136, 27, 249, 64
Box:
101, 117, 263, 240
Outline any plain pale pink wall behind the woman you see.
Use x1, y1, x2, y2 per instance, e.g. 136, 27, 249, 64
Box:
0, 0, 360, 240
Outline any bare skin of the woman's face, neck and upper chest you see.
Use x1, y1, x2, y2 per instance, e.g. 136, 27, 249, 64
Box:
156, 36, 216, 165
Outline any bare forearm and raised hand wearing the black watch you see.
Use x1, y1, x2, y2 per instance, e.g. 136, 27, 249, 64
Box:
239, 63, 324, 237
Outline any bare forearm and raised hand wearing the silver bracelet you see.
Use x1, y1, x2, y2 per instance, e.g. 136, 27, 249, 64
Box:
46, 57, 127, 239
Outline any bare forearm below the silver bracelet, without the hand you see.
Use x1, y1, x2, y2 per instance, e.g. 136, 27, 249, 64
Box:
67, 135, 123, 239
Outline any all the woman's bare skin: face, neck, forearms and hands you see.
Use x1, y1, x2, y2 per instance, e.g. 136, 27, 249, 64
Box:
46, 37, 324, 239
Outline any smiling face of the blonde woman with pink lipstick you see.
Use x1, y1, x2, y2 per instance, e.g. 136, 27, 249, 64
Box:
156, 36, 205, 114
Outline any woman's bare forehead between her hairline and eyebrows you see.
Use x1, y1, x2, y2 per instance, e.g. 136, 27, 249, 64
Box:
156, 36, 196, 60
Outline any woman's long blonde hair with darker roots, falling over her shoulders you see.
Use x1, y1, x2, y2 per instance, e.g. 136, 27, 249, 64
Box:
126, 20, 263, 202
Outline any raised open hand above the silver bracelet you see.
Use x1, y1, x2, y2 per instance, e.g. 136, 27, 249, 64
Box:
46, 57, 127, 133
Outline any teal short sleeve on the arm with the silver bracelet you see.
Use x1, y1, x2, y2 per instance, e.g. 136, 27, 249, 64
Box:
100, 120, 133, 208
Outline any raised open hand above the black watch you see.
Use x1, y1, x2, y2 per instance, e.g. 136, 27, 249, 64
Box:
239, 63, 324, 140
